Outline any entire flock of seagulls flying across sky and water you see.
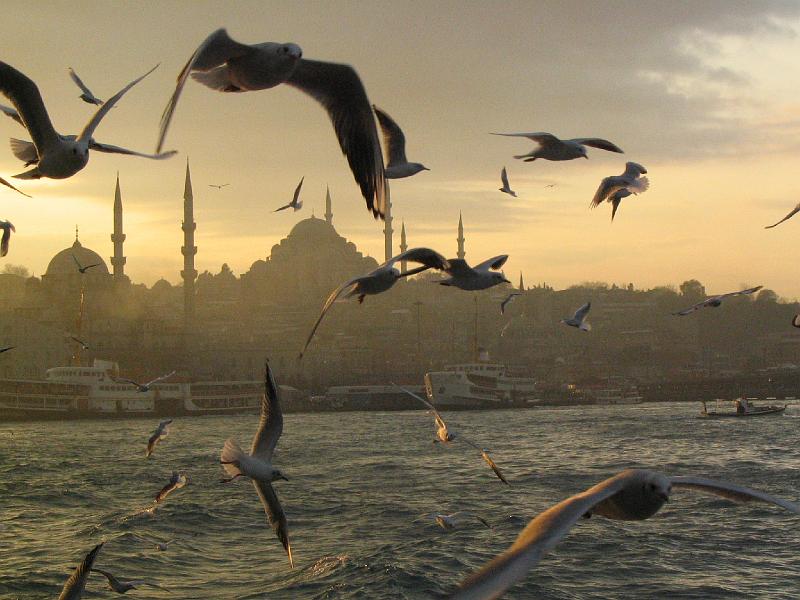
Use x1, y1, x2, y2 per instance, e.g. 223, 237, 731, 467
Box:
0, 29, 800, 600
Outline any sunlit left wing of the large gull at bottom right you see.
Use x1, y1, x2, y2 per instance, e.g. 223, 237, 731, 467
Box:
450, 473, 630, 600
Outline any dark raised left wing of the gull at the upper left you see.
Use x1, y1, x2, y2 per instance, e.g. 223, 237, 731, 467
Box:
0, 62, 61, 156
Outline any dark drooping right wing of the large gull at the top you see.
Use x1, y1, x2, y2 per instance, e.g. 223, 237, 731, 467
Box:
286, 58, 389, 219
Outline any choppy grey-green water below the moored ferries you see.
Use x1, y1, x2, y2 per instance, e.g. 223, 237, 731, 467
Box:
0, 404, 800, 599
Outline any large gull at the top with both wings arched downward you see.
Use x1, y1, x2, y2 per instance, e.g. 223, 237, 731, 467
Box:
156, 29, 389, 219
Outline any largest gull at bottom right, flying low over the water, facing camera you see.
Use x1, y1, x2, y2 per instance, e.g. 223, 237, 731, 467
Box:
450, 469, 800, 600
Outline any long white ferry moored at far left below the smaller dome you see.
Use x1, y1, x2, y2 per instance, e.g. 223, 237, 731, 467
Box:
0, 359, 264, 421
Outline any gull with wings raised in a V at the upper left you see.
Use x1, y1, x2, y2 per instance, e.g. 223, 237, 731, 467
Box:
0, 62, 175, 179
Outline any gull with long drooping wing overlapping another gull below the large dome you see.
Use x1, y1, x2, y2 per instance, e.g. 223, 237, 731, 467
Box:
298, 248, 449, 359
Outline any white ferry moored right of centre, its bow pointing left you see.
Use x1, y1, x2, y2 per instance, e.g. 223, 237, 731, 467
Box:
425, 362, 540, 409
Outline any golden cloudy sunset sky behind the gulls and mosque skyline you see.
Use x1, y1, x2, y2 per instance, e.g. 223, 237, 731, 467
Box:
0, 0, 800, 298
